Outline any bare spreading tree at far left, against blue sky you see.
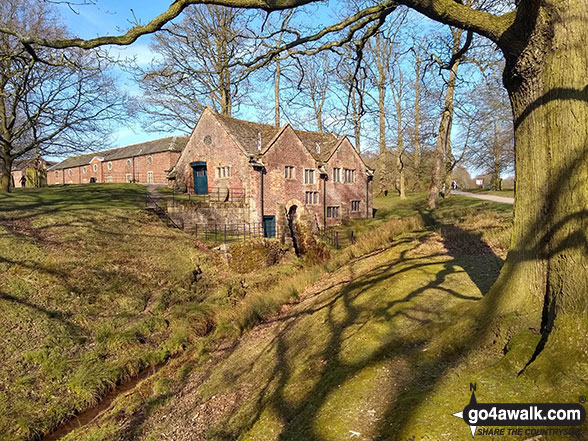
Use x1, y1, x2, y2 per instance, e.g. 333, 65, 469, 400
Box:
0, 0, 125, 191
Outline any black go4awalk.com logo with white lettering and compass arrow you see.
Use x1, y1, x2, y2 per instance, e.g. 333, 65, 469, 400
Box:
453, 383, 586, 437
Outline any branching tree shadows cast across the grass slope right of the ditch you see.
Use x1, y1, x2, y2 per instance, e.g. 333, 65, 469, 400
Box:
192, 234, 496, 441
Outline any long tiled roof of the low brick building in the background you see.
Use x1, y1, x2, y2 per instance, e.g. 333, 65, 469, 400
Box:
50, 136, 188, 170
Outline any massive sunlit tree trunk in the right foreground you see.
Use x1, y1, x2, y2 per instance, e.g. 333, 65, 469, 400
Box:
489, 0, 588, 332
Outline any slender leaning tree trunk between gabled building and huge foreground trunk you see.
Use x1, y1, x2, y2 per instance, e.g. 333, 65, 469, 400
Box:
428, 61, 459, 210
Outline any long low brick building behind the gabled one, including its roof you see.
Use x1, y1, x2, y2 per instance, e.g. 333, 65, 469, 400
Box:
47, 136, 188, 185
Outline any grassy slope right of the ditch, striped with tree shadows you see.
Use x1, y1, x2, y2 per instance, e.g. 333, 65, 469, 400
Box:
60, 195, 588, 441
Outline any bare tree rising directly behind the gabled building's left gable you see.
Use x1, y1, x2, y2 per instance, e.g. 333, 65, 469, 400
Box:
133, 5, 257, 132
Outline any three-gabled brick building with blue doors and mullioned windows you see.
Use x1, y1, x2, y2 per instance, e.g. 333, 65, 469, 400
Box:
174, 107, 373, 237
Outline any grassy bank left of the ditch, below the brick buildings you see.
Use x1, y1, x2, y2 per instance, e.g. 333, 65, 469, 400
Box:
0, 184, 310, 440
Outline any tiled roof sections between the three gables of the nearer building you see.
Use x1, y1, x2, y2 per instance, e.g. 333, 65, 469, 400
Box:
213, 112, 339, 161
